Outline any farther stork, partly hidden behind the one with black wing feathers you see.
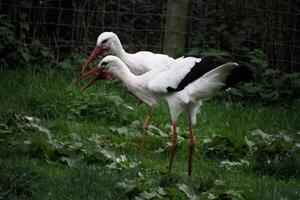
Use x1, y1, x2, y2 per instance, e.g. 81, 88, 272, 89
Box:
82, 32, 175, 150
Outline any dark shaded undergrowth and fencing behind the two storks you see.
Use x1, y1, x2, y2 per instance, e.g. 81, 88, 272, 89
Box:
0, 0, 300, 102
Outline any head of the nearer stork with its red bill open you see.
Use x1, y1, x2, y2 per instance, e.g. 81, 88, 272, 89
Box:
74, 56, 126, 91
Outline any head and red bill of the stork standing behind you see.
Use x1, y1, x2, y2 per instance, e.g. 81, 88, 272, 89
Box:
82, 32, 124, 72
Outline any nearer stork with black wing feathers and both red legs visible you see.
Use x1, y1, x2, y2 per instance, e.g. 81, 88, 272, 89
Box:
78, 56, 253, 178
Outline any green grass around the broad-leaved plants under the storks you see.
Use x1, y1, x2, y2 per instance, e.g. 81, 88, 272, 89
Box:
0, 69, 300, 199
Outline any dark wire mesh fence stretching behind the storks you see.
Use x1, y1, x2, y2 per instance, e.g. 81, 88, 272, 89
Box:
0, 0, 300, 71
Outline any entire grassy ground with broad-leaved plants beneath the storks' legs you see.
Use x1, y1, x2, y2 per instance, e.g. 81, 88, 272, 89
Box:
0, 69, 300, 199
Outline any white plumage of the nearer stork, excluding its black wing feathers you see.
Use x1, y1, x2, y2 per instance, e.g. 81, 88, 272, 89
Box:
104, 56, 237, 124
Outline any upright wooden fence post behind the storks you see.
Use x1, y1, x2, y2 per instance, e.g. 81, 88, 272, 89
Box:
163, 0, 190, 56
